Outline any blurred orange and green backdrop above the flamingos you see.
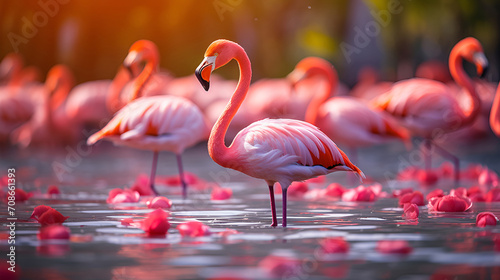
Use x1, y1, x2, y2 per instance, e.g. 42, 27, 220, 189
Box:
0, 0, 500, 86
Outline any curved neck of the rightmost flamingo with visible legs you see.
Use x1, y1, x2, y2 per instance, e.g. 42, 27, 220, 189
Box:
449, 47, 481, 125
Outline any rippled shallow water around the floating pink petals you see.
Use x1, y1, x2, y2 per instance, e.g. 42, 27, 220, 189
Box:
0, 138, 500, 279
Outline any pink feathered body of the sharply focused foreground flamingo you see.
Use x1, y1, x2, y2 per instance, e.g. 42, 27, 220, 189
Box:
230, 119, 364, 182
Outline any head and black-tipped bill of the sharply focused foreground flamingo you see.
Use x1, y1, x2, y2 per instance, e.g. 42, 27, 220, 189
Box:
195, 39, 243, 91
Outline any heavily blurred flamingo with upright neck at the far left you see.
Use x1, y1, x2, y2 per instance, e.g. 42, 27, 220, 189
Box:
11, 64, 78, 148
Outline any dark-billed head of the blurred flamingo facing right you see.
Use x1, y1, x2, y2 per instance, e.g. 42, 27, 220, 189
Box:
450, 37, 488, 77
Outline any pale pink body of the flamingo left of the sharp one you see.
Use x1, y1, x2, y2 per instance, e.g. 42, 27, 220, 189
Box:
87, 96, 208, 154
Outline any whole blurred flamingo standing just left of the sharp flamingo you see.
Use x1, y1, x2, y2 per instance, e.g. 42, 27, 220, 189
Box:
87, 40, 209, 197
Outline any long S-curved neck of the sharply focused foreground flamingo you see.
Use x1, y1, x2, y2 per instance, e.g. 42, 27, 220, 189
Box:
208, 45, 252, 167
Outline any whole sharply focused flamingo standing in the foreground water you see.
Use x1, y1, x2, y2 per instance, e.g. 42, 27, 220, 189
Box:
195, 40, 364, 227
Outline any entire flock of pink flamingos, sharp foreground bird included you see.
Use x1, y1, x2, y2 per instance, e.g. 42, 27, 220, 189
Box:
0, 37, 500, 227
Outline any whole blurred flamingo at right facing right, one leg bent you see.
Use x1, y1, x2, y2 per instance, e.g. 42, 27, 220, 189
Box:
372, 37, 488, 182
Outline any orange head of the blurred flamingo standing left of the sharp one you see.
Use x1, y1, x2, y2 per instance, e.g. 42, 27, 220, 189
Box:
123, 40, 160, 77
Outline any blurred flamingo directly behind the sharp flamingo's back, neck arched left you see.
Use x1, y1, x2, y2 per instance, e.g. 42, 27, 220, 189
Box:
288, 57, 410, 162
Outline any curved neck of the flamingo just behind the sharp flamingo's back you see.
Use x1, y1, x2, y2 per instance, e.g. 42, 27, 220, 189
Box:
305, 64, 338, 124
